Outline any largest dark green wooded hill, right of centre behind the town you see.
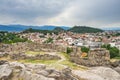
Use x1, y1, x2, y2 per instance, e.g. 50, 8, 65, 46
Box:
68, 26, 103, 33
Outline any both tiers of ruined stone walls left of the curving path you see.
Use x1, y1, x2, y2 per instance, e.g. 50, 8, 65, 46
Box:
0, 43, 62, 60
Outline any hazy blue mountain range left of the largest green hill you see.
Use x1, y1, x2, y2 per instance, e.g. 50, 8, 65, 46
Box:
0, 25, 70, 32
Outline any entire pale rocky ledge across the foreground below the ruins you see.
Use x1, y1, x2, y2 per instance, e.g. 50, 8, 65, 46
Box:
0, 60, 120, 80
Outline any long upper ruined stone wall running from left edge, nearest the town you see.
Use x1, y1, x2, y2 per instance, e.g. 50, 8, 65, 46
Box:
0, 42, 67, 53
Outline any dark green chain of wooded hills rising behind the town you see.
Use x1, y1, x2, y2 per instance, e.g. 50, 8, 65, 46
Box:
23, 26, 103, 34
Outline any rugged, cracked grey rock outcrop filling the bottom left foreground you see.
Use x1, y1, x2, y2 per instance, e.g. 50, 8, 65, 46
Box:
0, 62, 79, 80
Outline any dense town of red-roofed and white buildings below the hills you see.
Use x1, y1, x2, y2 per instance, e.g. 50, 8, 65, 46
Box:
21, 31, 120, 49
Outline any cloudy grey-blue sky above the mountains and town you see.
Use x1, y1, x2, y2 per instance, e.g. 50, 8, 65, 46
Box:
0, 0, 120, 28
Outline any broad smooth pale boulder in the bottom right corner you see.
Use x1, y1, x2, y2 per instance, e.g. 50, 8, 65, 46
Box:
72, 67, 120, 80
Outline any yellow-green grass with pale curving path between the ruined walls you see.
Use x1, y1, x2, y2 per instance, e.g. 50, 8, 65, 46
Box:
19, 51, 87, 70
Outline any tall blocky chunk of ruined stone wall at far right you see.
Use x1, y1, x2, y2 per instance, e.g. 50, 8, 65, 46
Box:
88, 49, 110, 65
